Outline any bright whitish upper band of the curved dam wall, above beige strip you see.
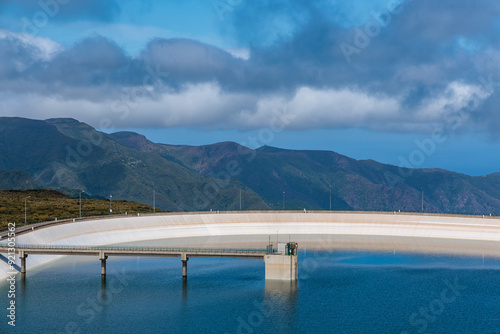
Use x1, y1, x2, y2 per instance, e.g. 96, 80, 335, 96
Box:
0, 211, 500, 276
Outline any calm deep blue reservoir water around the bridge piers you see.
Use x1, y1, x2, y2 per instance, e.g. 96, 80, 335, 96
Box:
0, 251, 500, 334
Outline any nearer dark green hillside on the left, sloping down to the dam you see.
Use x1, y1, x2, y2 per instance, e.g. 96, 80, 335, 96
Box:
0, 117, 266, 211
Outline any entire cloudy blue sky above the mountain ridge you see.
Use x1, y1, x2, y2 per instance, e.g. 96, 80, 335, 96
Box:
0, 0, 500, 175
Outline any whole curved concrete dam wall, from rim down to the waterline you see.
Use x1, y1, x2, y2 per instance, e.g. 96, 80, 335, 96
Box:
0, 211, 500, 280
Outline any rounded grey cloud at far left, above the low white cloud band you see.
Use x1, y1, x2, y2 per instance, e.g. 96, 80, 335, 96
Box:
0, 35, 132, 97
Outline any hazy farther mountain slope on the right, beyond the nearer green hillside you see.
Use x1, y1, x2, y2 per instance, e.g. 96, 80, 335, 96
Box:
150, 141, 500, 214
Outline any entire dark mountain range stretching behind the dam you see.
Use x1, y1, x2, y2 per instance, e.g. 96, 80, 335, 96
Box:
0, 117, 500, 214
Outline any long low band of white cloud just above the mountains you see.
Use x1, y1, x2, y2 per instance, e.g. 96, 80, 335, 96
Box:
0, 82, 489, 131
